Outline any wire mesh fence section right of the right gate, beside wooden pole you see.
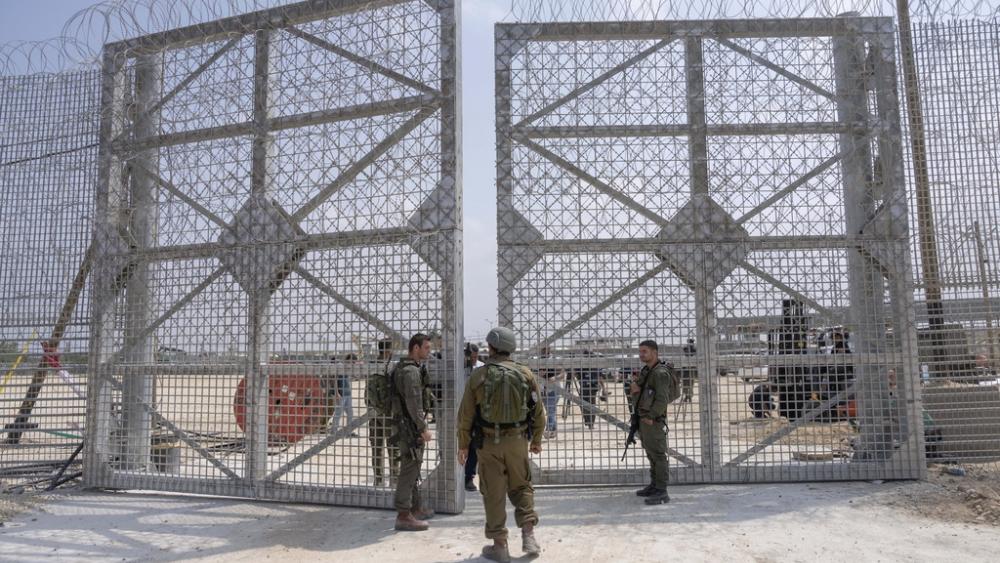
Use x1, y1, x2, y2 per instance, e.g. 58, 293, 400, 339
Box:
908, 20, 1000, 464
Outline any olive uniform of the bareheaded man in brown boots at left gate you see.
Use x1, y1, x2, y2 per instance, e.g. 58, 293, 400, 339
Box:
391, 358, 427, 511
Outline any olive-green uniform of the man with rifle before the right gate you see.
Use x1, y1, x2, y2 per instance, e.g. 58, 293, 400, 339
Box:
635, 362, 674, 497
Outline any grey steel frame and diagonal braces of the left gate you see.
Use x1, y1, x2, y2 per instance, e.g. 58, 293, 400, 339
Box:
84, 0, 465, 513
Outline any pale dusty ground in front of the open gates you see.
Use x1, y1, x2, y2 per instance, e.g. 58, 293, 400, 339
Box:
0, 466, 1000, 563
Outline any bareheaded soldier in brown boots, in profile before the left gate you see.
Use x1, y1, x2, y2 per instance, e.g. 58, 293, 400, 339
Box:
391, 333, 434, 532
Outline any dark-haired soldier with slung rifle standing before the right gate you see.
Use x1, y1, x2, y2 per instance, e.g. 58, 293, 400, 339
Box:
629, 340, 680, 504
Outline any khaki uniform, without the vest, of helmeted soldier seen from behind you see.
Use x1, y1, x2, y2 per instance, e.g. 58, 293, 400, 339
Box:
458, 356, 545, 540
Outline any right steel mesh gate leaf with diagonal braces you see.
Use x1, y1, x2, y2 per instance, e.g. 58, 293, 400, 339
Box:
496, 18, 923, 483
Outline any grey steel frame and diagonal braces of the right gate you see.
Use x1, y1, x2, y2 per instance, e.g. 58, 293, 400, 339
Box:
495, 14, 926, 484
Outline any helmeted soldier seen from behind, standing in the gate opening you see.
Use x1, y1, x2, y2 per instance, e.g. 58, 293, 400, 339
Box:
457, 327, 545, 561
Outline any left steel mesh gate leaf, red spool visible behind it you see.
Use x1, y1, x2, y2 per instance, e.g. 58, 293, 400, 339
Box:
86, 0, 463, 511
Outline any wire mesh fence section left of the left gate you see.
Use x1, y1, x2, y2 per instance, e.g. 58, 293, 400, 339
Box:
0, 71, 100, 488
